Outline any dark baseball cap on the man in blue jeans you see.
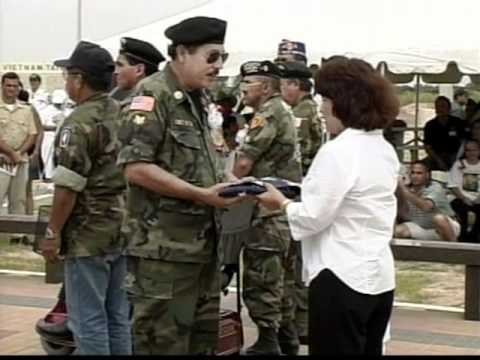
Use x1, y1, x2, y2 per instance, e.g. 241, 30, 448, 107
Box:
53, 41, 115, 78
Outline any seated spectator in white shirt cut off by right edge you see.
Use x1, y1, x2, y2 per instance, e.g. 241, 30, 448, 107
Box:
448, 140, 480, 242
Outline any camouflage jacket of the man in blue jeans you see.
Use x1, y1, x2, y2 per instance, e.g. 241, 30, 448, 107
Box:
52, 94, 126, 257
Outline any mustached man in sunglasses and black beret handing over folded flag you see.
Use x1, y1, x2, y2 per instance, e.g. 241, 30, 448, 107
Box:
118, 17, 234, 355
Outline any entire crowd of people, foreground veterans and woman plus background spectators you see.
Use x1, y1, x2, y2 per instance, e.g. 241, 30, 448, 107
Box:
0, 12, 480, 355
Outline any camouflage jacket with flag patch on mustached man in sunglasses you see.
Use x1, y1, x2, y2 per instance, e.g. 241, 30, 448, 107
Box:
118, 64, 223, 263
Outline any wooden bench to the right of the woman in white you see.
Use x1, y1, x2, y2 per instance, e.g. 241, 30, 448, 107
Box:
391, 239, 480, 320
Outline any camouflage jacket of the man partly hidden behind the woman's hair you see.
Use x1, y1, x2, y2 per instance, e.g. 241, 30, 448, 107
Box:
292, 95, 322, 175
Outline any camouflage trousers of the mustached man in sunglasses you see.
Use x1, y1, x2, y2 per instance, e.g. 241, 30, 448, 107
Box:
126, 257, 220, 355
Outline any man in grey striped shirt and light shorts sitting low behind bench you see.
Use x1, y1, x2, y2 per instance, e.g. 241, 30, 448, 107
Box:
395, 161, 460, 241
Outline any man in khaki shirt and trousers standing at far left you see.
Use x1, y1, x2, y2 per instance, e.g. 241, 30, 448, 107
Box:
0, 72, 37, 233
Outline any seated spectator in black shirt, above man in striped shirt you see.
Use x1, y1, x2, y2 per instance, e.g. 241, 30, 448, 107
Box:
424, 96, 464, 171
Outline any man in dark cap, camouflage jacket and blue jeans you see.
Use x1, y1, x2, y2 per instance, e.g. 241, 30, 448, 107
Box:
40, 41, 132, 355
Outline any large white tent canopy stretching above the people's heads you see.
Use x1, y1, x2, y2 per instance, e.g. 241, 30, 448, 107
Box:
95, 0, 480, 75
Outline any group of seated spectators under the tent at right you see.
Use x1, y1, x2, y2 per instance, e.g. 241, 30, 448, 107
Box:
395, 88, 480, 243
